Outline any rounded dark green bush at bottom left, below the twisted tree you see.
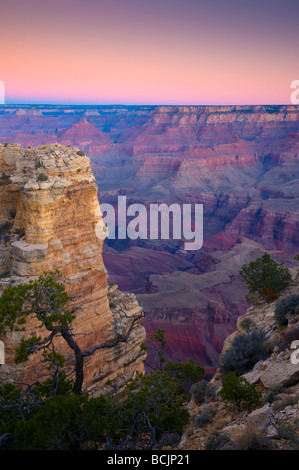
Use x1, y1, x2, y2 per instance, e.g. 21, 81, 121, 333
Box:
12, 394, 111, 450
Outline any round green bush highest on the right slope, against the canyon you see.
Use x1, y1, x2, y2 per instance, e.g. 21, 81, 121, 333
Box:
240, 253, 291, 302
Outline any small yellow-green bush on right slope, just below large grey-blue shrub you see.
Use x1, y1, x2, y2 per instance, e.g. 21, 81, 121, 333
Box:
219, 372, 261, 410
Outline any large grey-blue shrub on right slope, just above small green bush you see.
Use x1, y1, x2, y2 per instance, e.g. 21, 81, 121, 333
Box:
220, 330, 269, 375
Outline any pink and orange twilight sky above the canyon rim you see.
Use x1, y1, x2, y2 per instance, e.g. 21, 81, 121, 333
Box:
0, 0, 299, 105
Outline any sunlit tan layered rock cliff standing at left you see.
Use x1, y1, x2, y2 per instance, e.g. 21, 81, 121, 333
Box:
0, 144, 145, 392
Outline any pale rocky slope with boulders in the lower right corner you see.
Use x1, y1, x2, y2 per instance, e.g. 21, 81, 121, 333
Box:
180, 265, 299, 450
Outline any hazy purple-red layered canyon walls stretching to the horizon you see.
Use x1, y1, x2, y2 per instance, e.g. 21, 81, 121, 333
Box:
0, 105, 299, 374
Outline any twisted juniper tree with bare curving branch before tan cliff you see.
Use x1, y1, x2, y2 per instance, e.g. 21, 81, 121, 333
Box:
0, 271, 142, 394
